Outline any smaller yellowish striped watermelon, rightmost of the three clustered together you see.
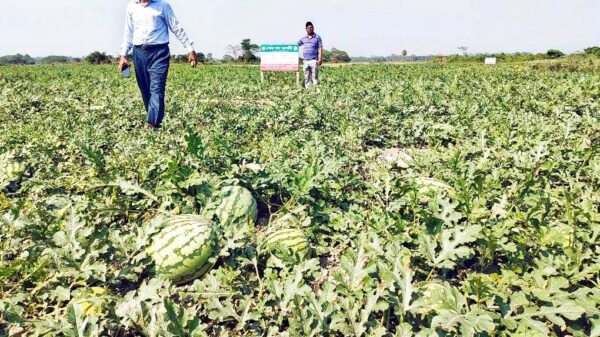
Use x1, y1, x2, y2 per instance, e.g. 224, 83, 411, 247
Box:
262, 227, 310, 260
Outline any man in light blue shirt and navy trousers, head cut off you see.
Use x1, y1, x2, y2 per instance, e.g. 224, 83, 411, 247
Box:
119, 0, 197, 128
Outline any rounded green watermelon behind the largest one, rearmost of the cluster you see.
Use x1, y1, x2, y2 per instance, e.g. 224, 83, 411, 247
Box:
214, 186, 258, 227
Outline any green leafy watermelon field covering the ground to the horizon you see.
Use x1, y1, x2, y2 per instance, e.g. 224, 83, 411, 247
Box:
0, 64, 600, 337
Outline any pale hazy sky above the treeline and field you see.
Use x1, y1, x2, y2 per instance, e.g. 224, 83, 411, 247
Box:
0, 0, 600, 57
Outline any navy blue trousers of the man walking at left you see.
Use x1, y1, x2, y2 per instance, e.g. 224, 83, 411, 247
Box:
133, 44, 170, 127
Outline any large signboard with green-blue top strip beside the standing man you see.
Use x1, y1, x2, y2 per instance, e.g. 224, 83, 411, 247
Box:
260, 44, 299, 72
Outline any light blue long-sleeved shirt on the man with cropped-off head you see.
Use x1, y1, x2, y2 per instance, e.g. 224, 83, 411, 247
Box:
121, 0, 194, 56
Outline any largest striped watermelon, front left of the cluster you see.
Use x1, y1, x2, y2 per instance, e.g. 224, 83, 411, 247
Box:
146, 215, 219, 283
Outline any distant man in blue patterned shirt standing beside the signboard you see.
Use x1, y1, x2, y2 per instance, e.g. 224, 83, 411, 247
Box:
298, 21, 323, 88
